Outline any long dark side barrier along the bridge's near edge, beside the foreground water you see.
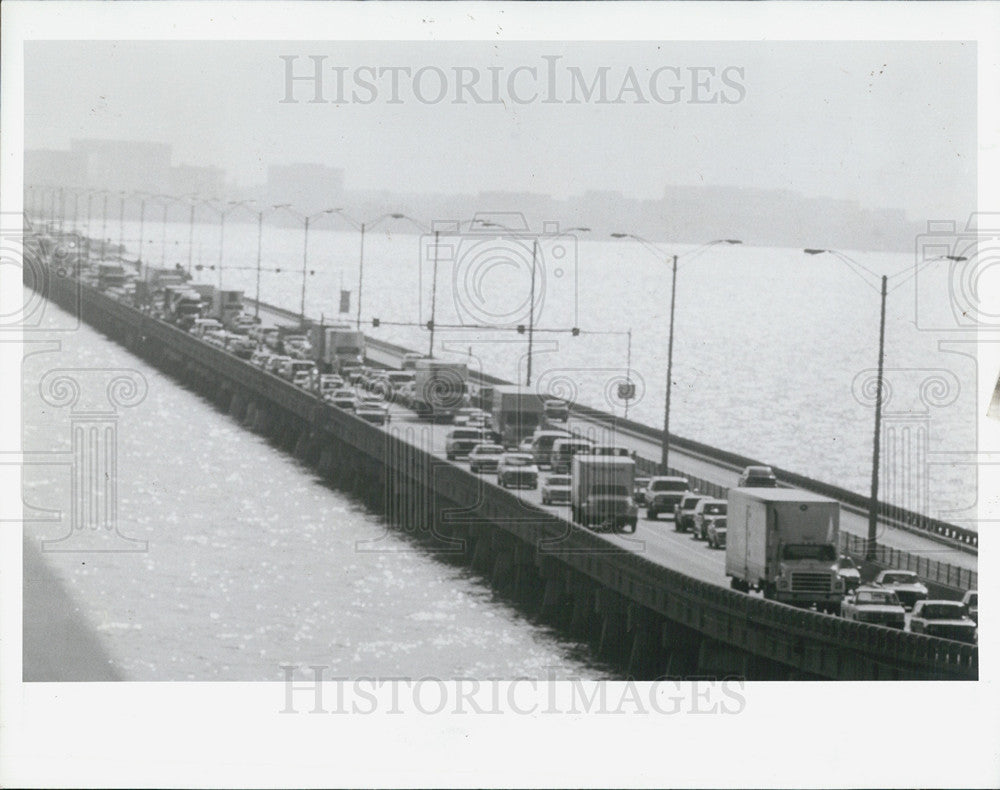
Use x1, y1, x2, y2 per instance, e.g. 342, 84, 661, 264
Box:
33, 262, 978, 679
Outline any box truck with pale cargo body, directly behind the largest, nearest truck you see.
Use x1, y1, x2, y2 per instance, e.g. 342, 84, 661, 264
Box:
570, 455, 639, 532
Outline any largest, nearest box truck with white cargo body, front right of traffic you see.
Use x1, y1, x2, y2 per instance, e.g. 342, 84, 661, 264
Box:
726, 488, 844, 613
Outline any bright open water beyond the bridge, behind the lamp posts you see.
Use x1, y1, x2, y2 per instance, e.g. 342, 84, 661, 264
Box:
88, 220, 982, 523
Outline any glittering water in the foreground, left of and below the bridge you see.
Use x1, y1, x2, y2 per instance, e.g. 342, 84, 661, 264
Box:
22, 305, 611, 680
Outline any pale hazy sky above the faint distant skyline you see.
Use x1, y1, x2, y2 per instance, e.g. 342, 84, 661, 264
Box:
25, 41, 976, 221
